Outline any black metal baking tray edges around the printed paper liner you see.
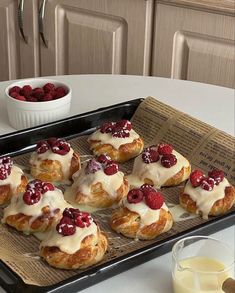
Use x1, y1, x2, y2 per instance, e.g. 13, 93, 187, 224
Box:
0, 99, 235, 293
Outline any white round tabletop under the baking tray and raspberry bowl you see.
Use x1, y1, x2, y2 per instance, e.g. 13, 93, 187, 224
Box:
0, 75, 235, 293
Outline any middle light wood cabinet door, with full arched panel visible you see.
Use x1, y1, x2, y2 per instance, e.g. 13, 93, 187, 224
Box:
40, 0, 153, 75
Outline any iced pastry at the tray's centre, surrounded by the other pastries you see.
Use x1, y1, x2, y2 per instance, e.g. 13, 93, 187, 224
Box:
71, 155, 129, 208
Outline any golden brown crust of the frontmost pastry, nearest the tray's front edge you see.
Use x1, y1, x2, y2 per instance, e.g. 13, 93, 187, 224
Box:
40, 229, 108, 269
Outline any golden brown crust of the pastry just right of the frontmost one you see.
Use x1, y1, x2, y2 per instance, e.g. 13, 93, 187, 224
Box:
110, 207, 173, 240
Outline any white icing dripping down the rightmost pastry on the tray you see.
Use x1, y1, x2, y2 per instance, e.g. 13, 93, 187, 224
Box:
184, 178, 230, 219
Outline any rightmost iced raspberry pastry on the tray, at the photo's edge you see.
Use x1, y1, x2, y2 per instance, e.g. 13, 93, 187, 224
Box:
179, 169, 235, 219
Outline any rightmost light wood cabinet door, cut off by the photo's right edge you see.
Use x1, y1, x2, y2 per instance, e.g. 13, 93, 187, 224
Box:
152, 1, 235, 87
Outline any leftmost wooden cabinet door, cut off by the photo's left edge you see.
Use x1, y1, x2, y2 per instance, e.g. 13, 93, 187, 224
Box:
0, 0, 39, 80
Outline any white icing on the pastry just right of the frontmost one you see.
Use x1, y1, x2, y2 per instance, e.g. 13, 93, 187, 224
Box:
123, 199, 168, 226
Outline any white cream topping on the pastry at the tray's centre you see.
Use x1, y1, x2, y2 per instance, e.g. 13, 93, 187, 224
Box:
72, 165, 124, 198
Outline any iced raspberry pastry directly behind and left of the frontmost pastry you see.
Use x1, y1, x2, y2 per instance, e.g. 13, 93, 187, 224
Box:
3, 179, 70, 234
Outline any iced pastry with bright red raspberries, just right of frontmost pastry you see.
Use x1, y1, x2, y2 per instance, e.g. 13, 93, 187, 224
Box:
111, 184, 173, 240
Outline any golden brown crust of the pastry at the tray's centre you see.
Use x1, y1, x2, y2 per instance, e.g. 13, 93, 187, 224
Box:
75, 177, 129, 208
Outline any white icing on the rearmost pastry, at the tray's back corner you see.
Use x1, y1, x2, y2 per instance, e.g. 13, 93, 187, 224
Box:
88, 129, 139, 150
